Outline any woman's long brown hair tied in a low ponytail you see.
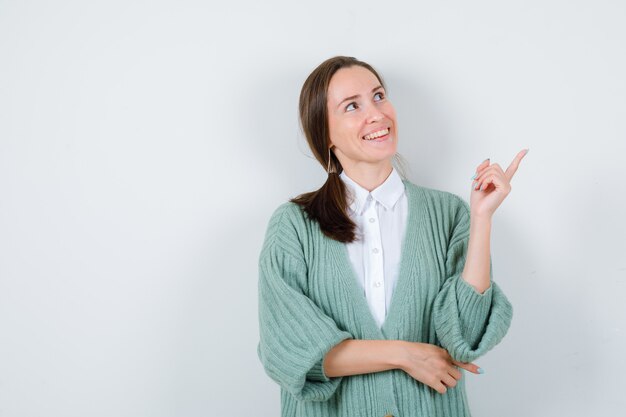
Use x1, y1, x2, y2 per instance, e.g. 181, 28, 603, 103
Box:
291, 56, 385, 243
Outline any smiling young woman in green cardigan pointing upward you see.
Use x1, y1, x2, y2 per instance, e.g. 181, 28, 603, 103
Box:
257, 56, 527, 417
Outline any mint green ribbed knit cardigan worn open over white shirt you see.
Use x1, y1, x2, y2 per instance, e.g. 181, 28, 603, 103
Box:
257, 180, 512, 417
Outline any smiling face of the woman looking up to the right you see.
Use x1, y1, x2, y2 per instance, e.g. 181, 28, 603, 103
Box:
327, 66, 398, 169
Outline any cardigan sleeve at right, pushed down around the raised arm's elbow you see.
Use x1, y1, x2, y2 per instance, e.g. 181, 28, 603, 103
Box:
433, 197, 513, 362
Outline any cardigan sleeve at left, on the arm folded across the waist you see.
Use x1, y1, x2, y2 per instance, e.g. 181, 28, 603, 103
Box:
257, 206, 352, 401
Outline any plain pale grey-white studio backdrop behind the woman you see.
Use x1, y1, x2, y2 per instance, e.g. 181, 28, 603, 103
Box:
0, 0, 626, 417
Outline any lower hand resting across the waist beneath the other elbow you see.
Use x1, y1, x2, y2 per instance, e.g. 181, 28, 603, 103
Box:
400, 342, 481, 394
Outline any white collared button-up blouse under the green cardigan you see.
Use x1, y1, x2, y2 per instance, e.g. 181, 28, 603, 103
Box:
340, 168, 408, 327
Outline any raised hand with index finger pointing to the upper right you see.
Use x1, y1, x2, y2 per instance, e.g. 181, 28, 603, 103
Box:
470, 149, 528, 218
